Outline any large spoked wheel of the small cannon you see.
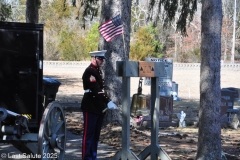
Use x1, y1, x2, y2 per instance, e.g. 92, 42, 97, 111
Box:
38, 102, 66, 160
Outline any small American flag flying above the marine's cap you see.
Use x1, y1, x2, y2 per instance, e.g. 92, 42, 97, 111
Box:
98, 15, 123, 42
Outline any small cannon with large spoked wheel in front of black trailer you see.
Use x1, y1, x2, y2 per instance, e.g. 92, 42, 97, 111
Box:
0, 102, 66, 160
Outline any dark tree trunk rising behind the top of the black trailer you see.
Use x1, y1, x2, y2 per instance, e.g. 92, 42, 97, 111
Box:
26, 0, 39, 23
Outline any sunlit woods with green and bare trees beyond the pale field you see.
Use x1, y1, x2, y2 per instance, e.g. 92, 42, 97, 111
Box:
0, 0, 240, 63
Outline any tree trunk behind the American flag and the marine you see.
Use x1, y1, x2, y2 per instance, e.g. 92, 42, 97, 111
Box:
99, 0, 132, 123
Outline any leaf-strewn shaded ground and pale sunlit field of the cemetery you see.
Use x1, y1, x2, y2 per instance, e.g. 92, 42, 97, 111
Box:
44, 65, 240, 160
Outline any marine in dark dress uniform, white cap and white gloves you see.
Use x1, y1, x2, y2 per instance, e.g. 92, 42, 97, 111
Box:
81, 50, 117, 160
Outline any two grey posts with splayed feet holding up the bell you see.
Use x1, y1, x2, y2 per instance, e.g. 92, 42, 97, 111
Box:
113, 61, 171, 160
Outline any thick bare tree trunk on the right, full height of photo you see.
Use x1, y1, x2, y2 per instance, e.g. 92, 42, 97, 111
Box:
196, 0, 222, 160
